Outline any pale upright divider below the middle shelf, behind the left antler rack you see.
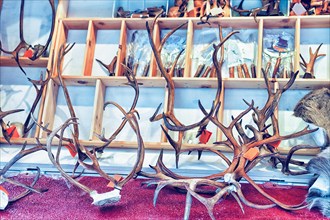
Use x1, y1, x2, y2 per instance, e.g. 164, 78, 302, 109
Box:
89, 80, 105, 140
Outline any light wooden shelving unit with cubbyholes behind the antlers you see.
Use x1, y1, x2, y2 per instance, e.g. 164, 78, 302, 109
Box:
0, 1, 330, 154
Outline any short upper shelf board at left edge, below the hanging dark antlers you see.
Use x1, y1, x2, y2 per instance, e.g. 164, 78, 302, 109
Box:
0, 56, 48, 67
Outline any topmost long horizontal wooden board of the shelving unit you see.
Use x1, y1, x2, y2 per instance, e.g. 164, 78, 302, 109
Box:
60, 15, 330, 29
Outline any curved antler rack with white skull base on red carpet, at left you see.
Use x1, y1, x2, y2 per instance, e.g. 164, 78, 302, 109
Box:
39, 45, 144, 205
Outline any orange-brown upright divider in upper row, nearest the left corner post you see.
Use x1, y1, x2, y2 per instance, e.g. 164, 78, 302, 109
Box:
83, 21, 96, 76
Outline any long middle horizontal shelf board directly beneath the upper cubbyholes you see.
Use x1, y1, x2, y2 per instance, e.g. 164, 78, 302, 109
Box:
54, 76, 330, 90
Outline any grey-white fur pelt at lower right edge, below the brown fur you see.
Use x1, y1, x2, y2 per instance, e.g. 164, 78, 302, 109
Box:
306, 147, 330, 218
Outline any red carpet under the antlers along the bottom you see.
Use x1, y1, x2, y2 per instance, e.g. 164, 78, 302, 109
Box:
0, 175, 326, 220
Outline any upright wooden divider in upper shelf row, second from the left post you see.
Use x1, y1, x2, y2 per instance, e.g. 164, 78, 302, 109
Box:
115, 20, 127, 76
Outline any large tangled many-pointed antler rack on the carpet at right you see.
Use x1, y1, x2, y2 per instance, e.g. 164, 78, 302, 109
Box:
140, 24, 316, 219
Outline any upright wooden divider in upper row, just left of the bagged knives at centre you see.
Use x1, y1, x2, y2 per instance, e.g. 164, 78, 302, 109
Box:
183, 20, 194, 77
